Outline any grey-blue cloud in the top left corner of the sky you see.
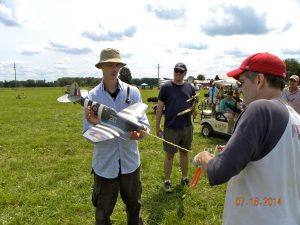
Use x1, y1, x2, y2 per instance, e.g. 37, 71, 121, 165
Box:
0, 0, 21, 27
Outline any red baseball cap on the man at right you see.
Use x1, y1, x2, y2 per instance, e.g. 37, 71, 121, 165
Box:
227, 52, 286, 80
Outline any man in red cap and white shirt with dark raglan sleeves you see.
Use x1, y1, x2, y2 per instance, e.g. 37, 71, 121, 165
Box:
194, 53, 300, 225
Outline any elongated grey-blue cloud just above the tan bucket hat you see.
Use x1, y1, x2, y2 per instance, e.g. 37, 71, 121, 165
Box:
81, 26, 137, 41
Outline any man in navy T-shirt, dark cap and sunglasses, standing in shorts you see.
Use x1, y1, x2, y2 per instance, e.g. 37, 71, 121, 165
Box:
156, 63, 196, 193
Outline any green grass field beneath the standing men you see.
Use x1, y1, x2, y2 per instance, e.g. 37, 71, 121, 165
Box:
0, 88, 226, 225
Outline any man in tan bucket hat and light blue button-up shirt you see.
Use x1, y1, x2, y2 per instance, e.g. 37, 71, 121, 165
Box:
83, 48, 150, 225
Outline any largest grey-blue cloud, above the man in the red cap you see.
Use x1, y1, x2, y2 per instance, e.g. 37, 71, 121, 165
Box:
201, 5, 271, 36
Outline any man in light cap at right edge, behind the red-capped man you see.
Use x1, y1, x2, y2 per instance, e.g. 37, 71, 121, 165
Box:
282, 75, 300, 114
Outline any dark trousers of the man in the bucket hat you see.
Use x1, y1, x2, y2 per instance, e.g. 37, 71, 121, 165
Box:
92, 168, 143, 225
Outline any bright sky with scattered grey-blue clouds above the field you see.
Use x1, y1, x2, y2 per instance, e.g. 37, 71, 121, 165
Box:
0, 0, 300, 82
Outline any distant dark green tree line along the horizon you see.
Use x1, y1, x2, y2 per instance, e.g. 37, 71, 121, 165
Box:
0, 59, 300, 88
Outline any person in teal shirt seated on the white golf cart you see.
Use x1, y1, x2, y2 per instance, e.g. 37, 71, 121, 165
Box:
219, 91, 240, 133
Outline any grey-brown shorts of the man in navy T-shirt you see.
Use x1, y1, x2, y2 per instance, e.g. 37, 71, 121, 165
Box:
163, 126, 193, 154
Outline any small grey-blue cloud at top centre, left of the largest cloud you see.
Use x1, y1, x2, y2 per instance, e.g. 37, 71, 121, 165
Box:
145, 5, 185, 20
